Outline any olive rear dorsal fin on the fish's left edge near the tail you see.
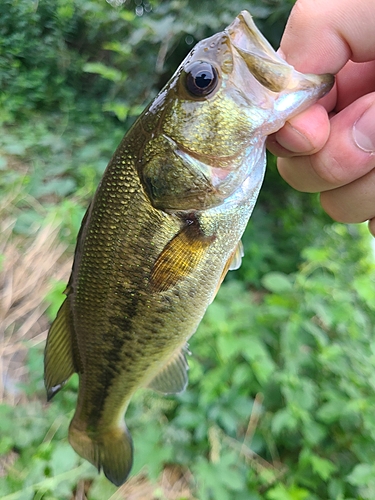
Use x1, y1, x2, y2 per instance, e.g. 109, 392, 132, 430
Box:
44, 297, 77, 401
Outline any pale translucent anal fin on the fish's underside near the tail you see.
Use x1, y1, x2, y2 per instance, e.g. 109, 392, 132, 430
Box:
148, 348, 189, 394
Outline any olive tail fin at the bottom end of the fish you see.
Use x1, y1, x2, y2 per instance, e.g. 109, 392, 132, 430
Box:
69, 419, 133, 486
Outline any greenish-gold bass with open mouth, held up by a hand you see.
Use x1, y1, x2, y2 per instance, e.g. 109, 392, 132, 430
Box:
44, 11, 334, 486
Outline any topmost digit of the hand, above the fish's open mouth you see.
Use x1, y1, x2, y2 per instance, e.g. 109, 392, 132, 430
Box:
280, 0, 375, 74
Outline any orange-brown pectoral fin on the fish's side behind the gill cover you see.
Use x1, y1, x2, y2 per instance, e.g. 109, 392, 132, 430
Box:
150, 220, 214, 292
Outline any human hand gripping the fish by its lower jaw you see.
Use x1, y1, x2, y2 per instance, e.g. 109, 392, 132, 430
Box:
267, 0, 375, 236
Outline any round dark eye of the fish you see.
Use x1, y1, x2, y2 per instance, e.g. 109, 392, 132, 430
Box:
186, 61, 219, 97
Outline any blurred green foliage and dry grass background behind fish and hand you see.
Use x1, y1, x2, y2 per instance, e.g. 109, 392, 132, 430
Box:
0, 0, 375, 500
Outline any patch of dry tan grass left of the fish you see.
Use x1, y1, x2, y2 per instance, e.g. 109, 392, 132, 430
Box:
0, 201, 71, 404
